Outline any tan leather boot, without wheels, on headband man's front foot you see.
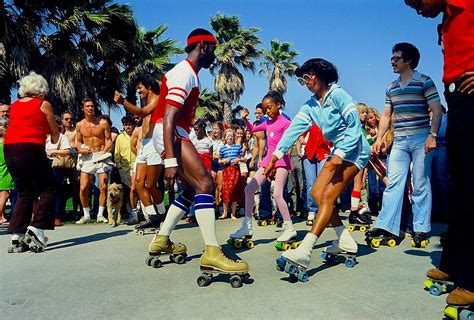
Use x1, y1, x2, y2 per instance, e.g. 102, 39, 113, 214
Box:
199, 246, 249, 273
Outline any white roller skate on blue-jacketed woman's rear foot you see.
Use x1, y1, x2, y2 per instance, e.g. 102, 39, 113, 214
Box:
321, 228, 357, 268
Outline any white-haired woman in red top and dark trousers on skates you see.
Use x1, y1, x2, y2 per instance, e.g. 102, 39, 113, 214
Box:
4, 72, 59, 253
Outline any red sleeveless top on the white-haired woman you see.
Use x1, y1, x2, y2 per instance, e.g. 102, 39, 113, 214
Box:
4, 98, 50, 145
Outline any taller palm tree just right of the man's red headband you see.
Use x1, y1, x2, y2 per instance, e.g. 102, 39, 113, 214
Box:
211, 14, 261, 124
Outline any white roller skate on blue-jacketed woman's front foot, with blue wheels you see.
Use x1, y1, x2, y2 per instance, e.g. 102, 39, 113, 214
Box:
276, 233, 317, 282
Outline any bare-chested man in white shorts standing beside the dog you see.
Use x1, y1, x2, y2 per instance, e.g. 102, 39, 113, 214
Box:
76, 98, 113, 224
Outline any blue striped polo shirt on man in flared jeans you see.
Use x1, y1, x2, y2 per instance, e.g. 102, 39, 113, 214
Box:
385, 71, 440, 136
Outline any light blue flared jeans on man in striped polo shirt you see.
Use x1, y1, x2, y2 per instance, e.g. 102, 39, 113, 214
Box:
375, 133, 431, 235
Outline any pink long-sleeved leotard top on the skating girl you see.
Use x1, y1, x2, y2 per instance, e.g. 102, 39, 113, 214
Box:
243, 114, 292, 170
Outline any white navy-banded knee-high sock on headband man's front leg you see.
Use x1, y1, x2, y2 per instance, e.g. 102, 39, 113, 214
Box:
193, 193, 219, 246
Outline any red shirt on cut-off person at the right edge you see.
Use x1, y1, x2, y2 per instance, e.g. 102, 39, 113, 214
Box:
441, 0, 474, 84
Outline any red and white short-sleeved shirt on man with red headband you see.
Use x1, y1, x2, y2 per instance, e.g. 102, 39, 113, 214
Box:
151, 59, 200, 133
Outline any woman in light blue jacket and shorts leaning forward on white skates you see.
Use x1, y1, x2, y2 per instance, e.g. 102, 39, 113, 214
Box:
265, 58, 370, 270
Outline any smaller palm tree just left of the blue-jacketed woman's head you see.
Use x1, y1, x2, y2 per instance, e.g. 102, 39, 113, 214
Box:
259, 40, 298, 94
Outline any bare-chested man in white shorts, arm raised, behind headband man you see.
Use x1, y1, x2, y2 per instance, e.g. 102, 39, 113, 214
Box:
114, 75, 166, 229
